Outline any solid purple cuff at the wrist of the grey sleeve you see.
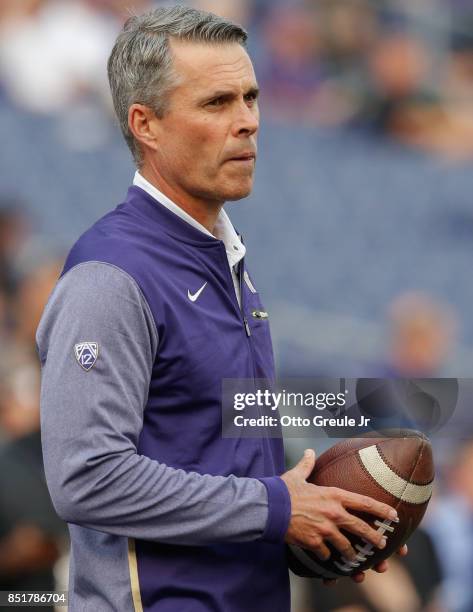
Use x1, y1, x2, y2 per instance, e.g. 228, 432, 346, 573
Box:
258, 476, 291, 542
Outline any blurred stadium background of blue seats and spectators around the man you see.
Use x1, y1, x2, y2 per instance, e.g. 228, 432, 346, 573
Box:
0, 0, 473, 612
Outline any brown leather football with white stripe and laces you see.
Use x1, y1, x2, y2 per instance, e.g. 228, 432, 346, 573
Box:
289, 430, 434, 578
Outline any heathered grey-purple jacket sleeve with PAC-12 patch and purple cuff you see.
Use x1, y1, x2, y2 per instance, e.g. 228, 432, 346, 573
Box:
36, 262, 290, 545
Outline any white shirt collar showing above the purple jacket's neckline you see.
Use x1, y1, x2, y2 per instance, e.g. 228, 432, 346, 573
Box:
133, 170, 246, 268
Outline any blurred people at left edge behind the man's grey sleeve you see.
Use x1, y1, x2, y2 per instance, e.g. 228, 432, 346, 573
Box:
0, 201, 68, 610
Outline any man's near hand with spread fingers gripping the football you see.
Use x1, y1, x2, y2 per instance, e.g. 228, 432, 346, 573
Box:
281, 450, 402, 582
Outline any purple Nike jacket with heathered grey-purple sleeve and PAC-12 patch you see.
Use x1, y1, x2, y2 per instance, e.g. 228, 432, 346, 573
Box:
37, 187, 290, 612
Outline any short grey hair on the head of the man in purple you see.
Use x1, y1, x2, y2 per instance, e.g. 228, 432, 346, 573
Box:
108, 5, 247, 167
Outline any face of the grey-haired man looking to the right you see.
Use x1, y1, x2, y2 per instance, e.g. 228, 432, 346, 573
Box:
145, 40, 259, 205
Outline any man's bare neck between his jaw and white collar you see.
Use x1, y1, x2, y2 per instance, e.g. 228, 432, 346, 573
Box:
139, 164, 224, 234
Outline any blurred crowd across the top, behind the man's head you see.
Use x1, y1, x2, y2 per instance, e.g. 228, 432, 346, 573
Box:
0, 0, 473, 158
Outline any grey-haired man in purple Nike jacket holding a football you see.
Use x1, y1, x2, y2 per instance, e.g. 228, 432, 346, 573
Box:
37, 6, 402, 612
